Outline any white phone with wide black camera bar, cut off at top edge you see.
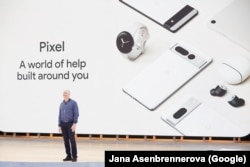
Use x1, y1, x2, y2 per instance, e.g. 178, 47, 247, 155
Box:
120, 0, 198, 32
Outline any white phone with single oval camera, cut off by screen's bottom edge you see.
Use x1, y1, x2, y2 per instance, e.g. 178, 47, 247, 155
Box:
161, 96, 249, 137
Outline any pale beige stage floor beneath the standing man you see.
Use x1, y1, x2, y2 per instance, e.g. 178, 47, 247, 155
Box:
0, 137, 250, 162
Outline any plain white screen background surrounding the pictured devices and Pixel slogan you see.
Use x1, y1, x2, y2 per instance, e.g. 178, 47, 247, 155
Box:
0, 0, 250, 136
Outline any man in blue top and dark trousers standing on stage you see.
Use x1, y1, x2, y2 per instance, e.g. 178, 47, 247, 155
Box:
58, 90, 79, 162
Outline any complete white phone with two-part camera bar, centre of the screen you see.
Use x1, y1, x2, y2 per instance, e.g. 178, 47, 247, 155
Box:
123, 43, 212, 110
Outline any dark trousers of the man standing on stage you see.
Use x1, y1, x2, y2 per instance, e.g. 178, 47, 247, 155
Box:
61, 123, 77, 158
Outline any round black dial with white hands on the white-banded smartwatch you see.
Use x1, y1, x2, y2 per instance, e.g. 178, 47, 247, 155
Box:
116, 31, 134, 53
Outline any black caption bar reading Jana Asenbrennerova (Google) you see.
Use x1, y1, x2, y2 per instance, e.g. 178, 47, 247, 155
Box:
105, 151, 250, 167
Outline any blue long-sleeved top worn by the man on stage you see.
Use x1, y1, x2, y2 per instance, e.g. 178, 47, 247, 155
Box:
58, 99, 79, 126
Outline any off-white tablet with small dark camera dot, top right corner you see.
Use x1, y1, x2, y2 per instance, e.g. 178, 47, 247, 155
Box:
208, 0, 250, 51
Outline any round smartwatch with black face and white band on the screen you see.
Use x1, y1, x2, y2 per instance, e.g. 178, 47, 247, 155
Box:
116, 23, 149, 60
